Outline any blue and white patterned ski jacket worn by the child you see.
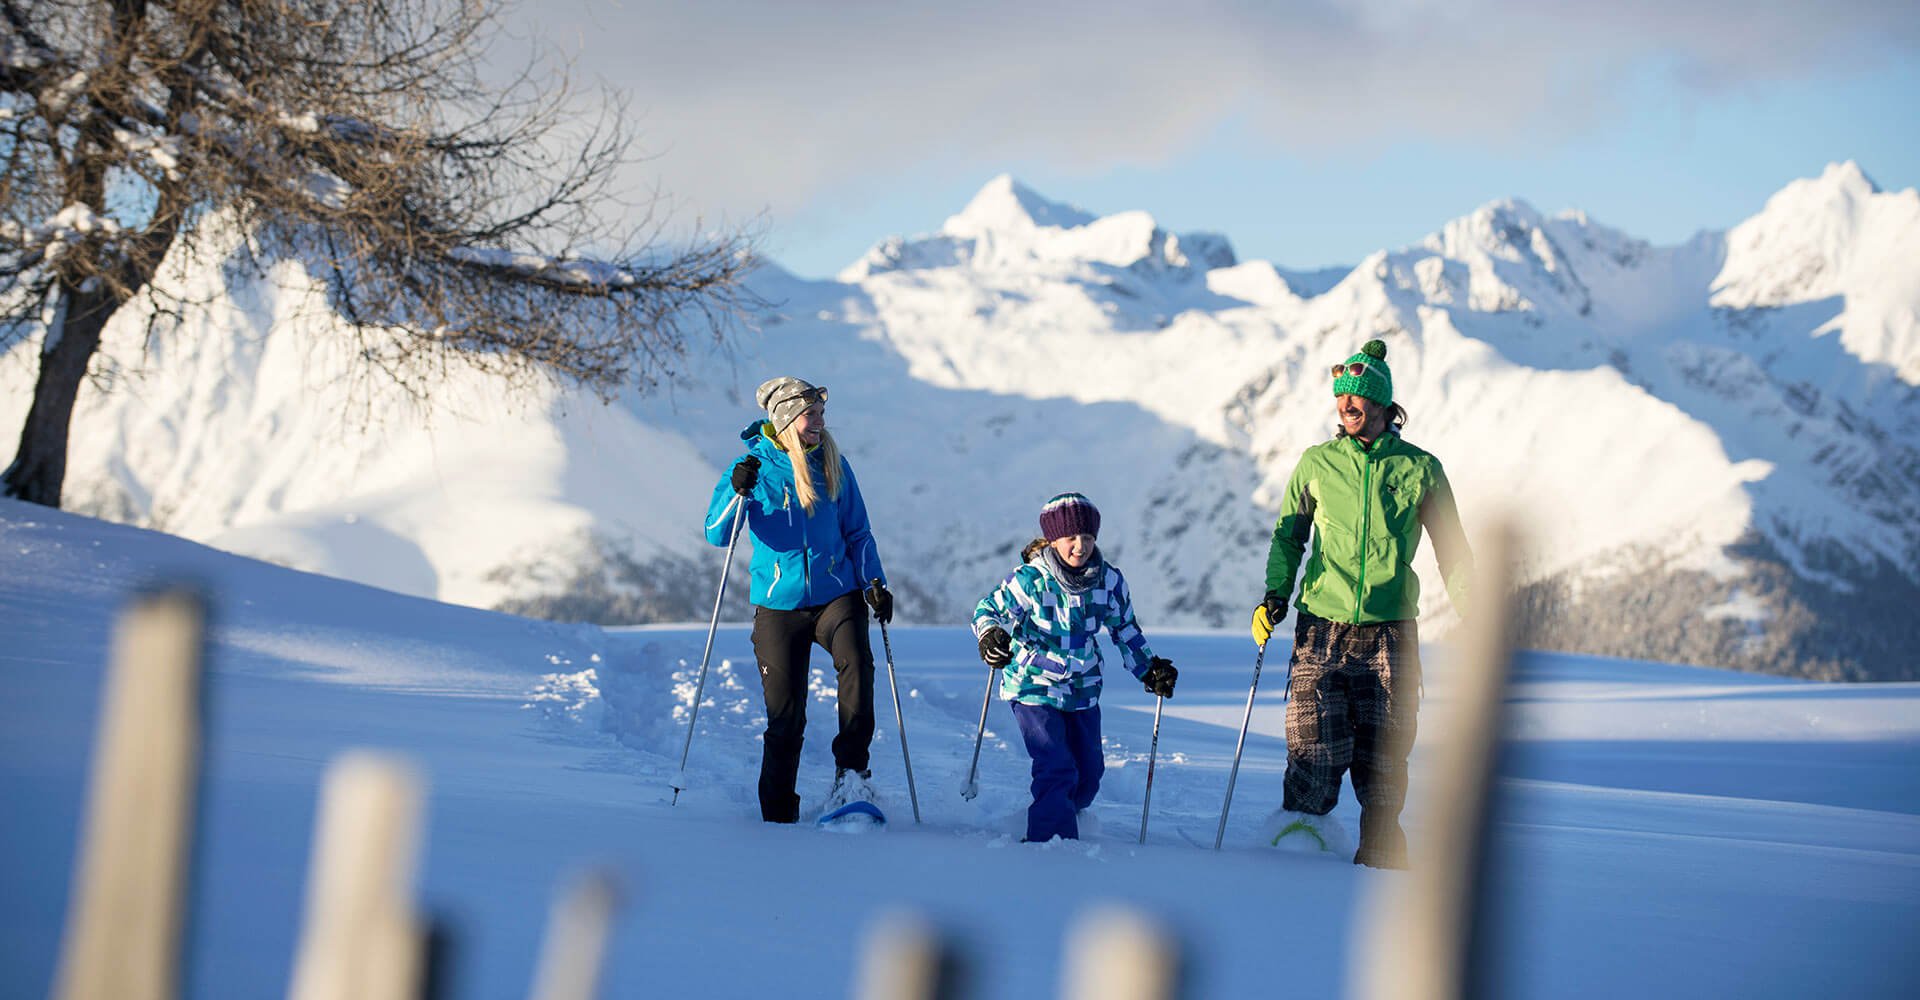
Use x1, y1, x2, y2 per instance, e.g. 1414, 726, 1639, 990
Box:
973, 545, 1154, 712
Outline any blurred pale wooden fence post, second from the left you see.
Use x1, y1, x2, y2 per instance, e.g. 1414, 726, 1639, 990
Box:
288, 752, 426, 1000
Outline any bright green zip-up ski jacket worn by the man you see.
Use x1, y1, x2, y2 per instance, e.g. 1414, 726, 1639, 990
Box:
1267, 432, 1473, 624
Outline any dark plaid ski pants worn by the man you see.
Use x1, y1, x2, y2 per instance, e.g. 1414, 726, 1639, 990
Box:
1284, 612, 1421, 843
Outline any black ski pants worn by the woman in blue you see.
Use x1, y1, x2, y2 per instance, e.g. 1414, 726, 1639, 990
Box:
753, 591, 874, 823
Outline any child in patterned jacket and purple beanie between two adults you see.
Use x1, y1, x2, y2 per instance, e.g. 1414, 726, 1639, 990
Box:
973, 493, 1179, 843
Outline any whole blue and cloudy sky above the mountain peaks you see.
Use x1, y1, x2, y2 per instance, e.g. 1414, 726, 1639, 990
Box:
514, 0, 1920, 276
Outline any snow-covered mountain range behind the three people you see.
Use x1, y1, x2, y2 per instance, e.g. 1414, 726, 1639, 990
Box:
0, 163, 1920, 679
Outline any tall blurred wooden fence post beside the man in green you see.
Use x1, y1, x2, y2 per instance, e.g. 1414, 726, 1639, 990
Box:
1348, 520, 1517, 1000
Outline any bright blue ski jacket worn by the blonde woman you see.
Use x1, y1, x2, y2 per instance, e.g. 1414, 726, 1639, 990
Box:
707, 420, 887, 610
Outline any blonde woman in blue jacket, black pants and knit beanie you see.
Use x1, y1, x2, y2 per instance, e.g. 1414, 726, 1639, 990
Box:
707, 376, 893, 823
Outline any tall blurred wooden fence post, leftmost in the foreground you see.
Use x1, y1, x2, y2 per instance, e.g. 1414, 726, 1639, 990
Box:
54, 589, 205, 1000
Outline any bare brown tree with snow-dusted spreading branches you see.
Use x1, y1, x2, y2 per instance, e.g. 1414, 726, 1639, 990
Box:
0, 0, 753, 507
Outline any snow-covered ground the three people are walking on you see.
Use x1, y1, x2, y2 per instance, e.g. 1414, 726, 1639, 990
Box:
0, 501, 1920, 998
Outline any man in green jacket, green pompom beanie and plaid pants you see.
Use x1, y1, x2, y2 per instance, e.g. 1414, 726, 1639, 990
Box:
1254, 340, 1473, 868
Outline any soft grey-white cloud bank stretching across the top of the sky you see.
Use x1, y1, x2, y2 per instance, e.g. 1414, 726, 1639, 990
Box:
522, 0, 1920, 226
